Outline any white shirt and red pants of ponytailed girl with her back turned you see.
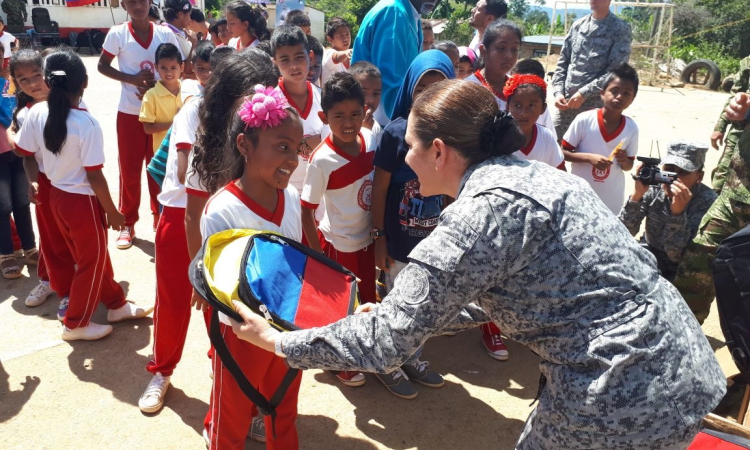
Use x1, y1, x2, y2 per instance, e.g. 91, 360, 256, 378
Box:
16, 102, 125, 329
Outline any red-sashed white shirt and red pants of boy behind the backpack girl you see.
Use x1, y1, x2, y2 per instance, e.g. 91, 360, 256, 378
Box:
302, 133, 375, 303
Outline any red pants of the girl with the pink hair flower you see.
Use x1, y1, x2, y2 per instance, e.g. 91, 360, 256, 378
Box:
206, 324, 302, 450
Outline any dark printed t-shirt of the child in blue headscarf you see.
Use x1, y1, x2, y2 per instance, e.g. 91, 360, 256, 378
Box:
374, 118, 445, 262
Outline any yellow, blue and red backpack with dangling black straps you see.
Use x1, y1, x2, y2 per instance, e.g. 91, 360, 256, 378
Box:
190, 229, 359, 430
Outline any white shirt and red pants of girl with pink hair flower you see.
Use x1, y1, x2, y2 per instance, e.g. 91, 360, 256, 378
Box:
201, 181, 302, 450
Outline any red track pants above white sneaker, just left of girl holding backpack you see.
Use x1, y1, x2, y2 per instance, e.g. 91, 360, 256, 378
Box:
146, 206, 193, 376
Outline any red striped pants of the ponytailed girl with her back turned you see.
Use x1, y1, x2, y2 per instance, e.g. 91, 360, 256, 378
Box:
49, 186, 126, 328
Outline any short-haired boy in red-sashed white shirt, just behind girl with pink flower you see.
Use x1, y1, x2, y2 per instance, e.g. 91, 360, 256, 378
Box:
302, 72, 375, 386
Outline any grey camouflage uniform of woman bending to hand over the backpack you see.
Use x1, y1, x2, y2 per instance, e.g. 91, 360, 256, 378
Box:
281, 156, 726, 450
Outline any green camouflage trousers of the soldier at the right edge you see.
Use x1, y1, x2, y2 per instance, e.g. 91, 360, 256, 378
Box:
674, 192, 750, 324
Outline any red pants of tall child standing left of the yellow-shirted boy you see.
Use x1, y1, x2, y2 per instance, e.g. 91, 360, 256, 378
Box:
117, 112, 159, 226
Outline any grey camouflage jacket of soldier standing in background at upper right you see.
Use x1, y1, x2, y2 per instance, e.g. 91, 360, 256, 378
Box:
552, 13, 633, 98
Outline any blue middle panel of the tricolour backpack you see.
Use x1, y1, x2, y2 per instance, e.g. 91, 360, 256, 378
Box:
245, 237, 307, 323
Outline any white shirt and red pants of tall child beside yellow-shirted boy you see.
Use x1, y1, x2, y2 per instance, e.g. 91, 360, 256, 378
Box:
102, 22, 184, 226
